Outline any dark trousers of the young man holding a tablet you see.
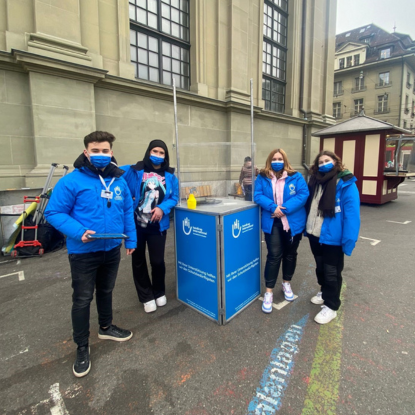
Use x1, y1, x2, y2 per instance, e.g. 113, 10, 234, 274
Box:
69, 246, 121, 346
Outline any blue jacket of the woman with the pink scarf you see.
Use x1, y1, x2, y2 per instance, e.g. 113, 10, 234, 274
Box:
254, 172, 309, 236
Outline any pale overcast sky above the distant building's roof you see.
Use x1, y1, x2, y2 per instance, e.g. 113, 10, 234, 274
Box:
336, 0, 415, 40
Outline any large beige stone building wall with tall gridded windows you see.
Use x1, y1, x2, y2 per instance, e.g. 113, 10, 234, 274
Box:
0, 0, 336, 190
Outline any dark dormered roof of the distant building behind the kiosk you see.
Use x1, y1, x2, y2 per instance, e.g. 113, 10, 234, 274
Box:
336, 24, 415, 63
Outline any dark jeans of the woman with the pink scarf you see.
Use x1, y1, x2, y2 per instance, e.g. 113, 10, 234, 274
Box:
264, 219, 302, 288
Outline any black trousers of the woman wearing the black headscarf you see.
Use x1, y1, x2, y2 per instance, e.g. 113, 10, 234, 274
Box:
132, 228, 167, 303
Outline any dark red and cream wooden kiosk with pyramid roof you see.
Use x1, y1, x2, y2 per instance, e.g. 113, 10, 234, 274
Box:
312, 115, 415, 204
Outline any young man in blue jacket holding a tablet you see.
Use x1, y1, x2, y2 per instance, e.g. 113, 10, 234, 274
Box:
45, 131, 137, 377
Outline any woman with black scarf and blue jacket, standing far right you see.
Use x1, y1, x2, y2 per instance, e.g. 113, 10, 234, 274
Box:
306, 150, 360, 324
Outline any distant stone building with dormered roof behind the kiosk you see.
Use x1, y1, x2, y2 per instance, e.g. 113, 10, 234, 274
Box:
333, 24, 415, 132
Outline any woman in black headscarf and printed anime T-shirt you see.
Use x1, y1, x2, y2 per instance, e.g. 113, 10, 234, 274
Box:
121, 140, 179, 313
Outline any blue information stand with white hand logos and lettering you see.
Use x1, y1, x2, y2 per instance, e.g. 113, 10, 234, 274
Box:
174, 199, 261, 324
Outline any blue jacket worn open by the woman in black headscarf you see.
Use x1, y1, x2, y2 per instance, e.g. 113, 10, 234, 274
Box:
121, 163, 179, 232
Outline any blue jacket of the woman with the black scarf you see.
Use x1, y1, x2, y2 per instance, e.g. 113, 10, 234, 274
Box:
320, 176, 360, 256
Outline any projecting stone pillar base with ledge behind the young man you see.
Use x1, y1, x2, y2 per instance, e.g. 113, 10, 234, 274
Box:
14, 51, 105, 186
